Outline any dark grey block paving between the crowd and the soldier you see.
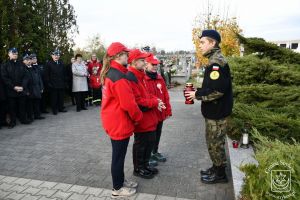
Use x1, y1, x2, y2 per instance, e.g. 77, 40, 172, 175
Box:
0, 89, 233, 200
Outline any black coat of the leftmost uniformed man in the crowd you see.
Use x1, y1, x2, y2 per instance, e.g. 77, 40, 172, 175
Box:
1, 60, 29, 97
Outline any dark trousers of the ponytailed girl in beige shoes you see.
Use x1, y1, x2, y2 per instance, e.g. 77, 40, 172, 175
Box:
111, 138, 129, 190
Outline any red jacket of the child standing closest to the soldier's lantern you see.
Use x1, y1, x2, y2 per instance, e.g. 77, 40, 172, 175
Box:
145, 74, 172, 122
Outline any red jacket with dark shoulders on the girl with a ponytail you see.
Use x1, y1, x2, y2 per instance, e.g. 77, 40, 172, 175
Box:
101, 61, 143, 140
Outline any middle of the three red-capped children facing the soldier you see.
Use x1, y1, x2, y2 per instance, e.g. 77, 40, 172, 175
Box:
127, 49, 164, 179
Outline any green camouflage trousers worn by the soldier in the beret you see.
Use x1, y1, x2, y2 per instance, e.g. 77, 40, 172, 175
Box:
205, 119, 227, 166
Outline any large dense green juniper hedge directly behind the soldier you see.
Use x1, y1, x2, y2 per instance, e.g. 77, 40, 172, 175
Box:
229, 55, 300, 142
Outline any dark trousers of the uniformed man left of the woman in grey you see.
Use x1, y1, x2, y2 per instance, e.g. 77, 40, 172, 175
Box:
50, 88, 64, 113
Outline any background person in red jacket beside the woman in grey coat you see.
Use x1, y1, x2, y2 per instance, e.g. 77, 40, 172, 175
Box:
88, 54, 102, 106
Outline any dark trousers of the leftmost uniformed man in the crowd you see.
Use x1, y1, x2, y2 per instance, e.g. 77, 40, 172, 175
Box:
8, 96, 26, 124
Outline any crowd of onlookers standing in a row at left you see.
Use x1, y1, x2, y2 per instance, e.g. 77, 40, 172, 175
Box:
0, 48, 102, 128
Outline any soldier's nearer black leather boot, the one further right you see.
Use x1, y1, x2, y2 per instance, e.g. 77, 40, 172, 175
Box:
201, 167, 228, 184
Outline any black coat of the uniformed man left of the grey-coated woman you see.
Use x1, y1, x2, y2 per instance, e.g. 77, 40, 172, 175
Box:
44, 60, 67, 89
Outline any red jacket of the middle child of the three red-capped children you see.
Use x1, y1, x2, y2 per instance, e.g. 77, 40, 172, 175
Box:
127, 67, 158, 133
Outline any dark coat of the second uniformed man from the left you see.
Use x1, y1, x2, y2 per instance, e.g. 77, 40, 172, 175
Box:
26, 66, 44, 99
